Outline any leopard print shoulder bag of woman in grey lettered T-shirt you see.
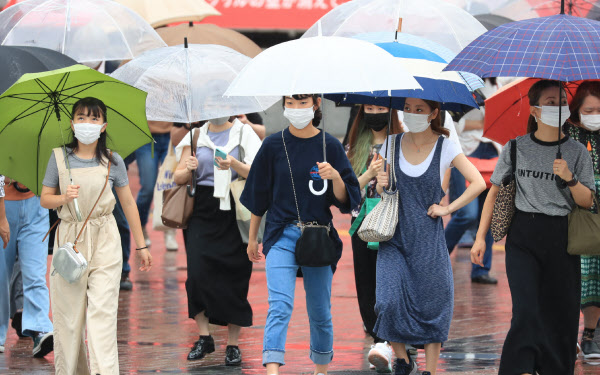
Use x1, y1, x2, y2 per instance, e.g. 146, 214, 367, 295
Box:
491, 139, 517, 242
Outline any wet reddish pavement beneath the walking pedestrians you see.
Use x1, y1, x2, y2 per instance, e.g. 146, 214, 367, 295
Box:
0, 171, 600, 375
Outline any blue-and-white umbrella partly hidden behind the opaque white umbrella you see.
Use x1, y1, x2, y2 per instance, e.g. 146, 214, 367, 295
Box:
325, 41, 477, 111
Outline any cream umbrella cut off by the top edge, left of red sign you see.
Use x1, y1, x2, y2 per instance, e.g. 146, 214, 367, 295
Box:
116, 0, 221, 27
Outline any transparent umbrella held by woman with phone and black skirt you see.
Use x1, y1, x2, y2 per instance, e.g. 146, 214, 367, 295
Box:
111, 44, 280, 123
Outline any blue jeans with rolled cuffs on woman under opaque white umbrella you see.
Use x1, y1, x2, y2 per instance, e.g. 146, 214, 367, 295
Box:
263, 225, 333, 365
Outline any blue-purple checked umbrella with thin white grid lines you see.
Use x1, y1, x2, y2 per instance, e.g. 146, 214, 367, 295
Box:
446, 14, 600, 82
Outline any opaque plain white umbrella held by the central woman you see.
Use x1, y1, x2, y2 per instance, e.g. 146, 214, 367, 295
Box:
225, 36, 421, 97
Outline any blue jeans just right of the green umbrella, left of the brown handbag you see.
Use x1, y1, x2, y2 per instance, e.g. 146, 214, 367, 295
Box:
135, 133, 171, 228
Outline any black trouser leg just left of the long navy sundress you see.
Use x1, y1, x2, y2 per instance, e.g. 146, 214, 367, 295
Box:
352, 219, 384, 343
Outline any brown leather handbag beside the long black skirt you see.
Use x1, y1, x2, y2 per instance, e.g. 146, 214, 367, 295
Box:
161, 128, 200, 229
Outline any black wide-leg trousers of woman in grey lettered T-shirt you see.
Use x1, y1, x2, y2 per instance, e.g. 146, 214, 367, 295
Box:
499, 212, 581, 375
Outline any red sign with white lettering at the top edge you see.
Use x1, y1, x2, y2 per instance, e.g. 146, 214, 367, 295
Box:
204, 0, 348, 30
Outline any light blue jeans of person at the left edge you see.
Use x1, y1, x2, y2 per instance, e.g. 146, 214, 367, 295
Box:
0, 197, 52, 345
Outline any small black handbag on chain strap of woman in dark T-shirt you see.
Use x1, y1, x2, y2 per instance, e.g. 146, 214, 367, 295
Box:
281, 132, 337, 267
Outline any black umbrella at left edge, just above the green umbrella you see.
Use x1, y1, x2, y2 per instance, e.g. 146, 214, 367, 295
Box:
0, 46, 77, 94
